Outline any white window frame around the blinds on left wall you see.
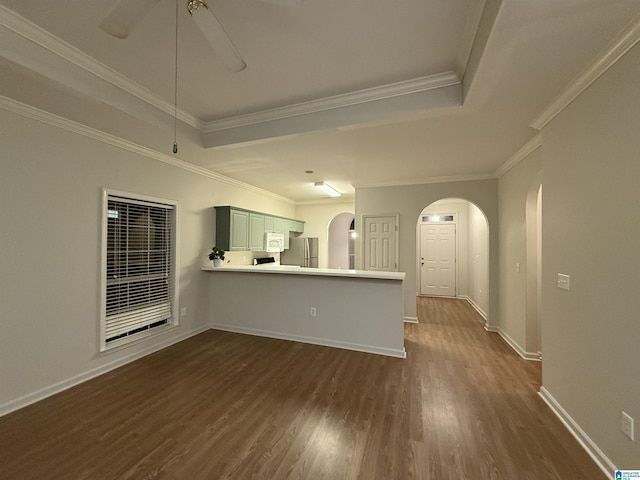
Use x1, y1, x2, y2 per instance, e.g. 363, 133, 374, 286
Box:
99, 188, 180, 352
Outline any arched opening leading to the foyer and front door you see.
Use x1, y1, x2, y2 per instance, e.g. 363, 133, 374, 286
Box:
416, 198, 489, 321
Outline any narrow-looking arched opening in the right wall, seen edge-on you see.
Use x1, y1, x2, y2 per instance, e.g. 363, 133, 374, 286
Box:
525, 179, 542, 358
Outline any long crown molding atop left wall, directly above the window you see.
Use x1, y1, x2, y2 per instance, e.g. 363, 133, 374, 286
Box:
0, 95, 295, 205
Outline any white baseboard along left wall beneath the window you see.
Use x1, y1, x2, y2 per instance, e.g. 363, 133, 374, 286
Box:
0, 325, 209, 417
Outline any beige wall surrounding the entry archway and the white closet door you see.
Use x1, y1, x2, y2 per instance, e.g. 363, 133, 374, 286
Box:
356, 180, 498, 324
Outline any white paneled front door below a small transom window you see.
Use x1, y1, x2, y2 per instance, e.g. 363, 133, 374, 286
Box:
420, 224, 456, 297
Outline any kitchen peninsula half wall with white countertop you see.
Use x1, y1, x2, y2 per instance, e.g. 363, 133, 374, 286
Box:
202, 265, 406, 358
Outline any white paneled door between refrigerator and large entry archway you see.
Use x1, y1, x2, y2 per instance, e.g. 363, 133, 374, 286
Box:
362, 215, 398, 272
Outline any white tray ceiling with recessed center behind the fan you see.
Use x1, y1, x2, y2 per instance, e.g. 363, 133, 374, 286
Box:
0, 0, 640, 202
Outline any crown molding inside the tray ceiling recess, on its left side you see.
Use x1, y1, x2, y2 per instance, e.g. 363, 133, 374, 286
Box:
0, 5, 204, 130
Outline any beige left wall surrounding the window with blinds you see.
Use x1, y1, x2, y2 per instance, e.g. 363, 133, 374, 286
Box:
0, 110, 295, 413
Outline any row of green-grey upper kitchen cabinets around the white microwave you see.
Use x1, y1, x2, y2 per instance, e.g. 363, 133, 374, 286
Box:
215, 206, 304, 252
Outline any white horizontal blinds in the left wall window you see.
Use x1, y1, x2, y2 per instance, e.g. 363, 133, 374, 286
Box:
105, 195, 174, 343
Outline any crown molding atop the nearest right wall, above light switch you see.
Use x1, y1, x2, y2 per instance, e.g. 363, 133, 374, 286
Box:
531, 11, 640, 130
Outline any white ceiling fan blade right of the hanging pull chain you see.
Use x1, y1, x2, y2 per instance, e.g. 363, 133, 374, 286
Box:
187, 0, 247, 72
